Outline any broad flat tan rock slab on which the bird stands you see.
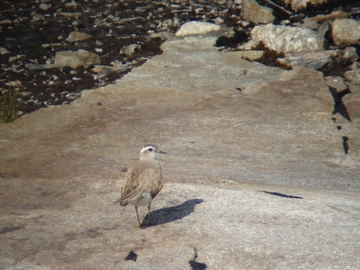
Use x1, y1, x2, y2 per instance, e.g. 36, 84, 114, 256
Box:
0, 33, 360, 269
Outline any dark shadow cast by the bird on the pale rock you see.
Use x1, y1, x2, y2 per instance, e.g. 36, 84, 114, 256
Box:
140, 199, 204, 228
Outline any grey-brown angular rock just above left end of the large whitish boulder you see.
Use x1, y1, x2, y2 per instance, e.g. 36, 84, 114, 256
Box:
241, 0, 275, 24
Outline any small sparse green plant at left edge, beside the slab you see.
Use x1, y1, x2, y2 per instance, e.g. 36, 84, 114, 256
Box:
0, 89, 18, 123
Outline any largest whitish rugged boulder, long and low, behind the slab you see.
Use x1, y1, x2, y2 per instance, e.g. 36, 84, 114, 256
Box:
240, 24, 324, 53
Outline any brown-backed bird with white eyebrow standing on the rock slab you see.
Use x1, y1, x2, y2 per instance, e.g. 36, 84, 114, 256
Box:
115, 144, 166, 227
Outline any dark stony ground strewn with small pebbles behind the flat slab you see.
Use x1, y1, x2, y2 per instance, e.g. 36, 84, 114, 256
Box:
0, 0, 360, 118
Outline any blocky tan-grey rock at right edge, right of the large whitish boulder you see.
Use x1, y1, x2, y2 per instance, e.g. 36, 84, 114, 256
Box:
331, 19, 360, 46
